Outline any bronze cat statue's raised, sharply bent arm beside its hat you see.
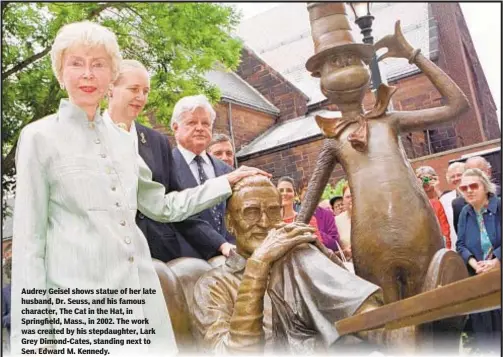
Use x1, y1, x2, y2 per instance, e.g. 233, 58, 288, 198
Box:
393, 53, 469, 132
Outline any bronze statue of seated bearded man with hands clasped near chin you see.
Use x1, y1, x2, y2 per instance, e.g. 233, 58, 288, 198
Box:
192, 176, 392, 354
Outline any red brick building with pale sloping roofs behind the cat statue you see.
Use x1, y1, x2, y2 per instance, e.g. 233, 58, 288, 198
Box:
163, 3, 501, 189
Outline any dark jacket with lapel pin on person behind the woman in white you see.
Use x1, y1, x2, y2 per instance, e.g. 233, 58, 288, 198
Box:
135, 123, 226, 262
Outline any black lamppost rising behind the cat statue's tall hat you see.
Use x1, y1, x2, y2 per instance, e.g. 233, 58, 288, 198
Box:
349, 2, 382, 90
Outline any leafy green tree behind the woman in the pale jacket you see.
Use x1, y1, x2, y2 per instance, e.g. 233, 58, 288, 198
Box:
1, 2, 241, 212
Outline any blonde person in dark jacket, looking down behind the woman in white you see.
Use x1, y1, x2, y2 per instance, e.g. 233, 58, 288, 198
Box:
103, 60, 233, 262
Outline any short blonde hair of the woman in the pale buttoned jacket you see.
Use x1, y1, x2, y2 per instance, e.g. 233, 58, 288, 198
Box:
51, 21, 122, 82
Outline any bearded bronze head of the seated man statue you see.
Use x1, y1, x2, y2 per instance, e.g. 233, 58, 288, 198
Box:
226, 175, 282, 258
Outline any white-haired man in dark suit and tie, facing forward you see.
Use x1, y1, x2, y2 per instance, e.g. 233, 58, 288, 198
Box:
171, 95, 235, 252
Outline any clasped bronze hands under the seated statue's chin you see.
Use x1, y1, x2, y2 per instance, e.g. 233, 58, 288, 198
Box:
252, 222, 316, 264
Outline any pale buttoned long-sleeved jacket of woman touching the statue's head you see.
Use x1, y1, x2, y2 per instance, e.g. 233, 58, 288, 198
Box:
11, 100, 231, 355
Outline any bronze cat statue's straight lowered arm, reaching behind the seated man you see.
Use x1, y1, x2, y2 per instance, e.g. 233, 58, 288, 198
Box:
296, 139, 337, 224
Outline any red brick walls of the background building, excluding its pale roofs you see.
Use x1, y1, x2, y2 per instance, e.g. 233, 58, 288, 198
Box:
147, 3, 500, 192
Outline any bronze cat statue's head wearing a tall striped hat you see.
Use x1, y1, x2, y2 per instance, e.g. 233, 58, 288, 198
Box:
306, 2, 374, 104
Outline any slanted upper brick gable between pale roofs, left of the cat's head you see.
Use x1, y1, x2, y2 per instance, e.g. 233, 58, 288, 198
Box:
236, 46, 308, 121
